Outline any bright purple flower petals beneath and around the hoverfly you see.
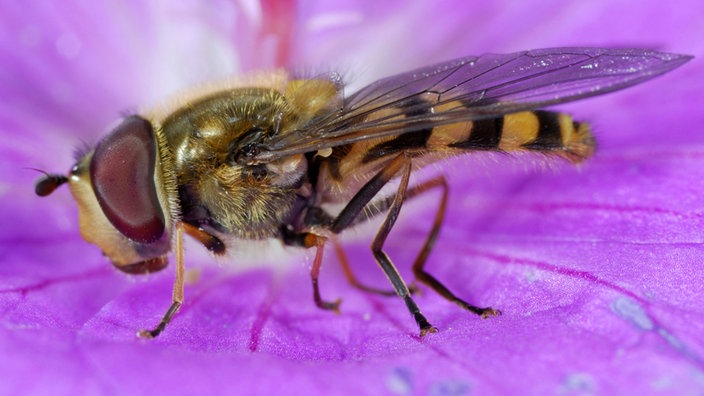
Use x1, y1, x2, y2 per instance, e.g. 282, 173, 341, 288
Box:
0, 0, 704, 395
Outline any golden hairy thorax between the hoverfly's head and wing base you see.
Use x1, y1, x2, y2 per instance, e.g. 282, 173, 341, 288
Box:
151, 76, 338, 239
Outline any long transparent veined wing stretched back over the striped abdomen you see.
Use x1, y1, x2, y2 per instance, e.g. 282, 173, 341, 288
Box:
253, 48, 692, 162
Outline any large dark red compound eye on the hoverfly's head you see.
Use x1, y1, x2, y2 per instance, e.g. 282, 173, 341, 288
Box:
90, 116, 166, 243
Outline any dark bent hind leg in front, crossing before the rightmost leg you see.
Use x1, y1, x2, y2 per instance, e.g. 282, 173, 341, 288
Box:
331, 154, 437, 337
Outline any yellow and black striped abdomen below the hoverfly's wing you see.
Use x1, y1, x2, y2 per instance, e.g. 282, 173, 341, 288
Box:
324, 110, 595, 189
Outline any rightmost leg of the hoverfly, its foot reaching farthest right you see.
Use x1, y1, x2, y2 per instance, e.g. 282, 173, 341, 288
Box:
413, 177, 501, 318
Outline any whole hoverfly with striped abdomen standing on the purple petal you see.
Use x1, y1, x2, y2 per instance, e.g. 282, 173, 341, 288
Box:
36, 48, 692, 337
